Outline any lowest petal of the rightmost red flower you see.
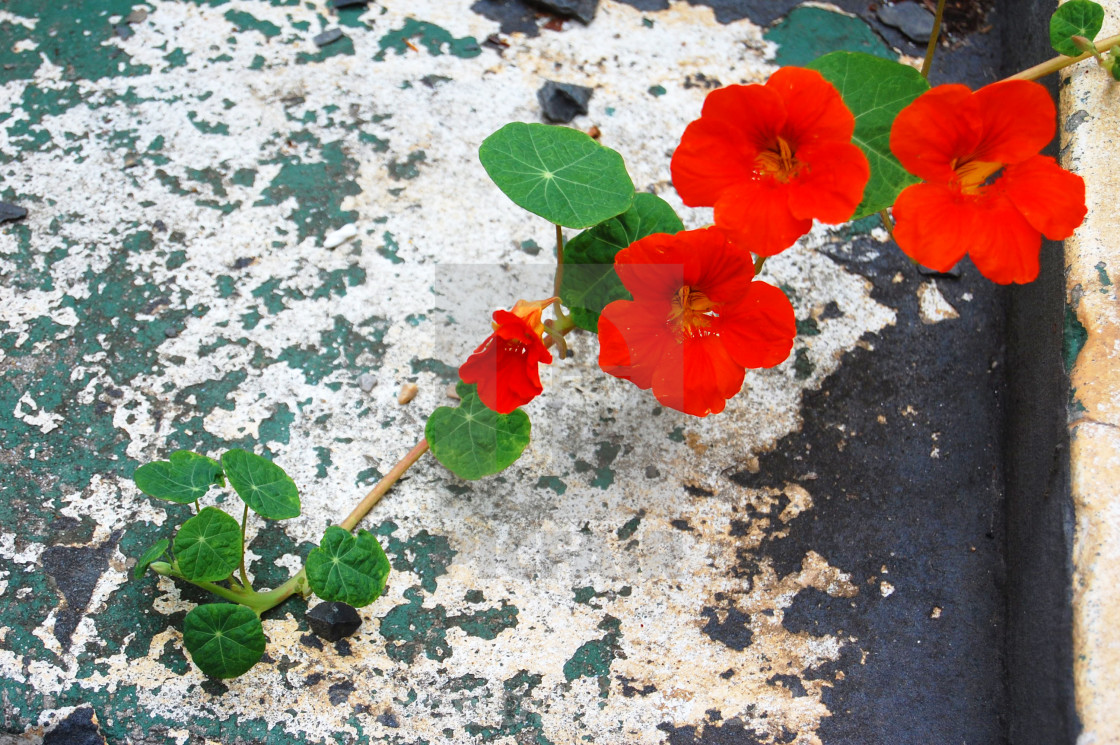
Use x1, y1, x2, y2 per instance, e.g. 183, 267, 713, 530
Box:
969, 196, 1043, 285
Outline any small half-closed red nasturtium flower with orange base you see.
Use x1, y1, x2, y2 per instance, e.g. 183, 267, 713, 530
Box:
459, 298, 556, 413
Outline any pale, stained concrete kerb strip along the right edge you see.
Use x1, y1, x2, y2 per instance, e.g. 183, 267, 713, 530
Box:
1062, 0, 1120, 745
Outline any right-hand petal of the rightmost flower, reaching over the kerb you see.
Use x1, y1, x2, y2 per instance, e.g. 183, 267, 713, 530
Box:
992, 156, 1088, 241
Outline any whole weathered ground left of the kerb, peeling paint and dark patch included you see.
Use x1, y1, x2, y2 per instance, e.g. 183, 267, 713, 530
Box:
0, 0, 1114, 745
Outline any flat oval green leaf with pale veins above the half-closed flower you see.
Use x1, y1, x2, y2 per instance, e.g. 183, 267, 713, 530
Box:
478, 122, 634, 227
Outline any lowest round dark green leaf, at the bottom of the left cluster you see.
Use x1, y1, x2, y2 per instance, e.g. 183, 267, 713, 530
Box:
183, 603, 264, 678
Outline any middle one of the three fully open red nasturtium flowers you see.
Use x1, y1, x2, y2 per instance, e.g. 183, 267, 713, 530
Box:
672, 67, 871, 257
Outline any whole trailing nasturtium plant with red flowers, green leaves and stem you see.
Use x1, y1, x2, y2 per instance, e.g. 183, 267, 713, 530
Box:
122, 0, 1102, 678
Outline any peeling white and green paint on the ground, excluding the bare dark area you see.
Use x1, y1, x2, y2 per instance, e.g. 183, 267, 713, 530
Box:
0, 0, 895, 745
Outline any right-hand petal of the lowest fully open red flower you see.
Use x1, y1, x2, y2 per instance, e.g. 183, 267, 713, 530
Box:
718, 281, 797, 367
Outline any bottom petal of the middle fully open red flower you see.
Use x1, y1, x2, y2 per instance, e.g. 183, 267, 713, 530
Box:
716, 178, 813, 257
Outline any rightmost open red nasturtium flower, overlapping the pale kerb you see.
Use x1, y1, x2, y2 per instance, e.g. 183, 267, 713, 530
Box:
890, 81, 1085, 285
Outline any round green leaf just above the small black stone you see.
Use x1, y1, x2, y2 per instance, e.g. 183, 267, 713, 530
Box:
307, 525, 389, 607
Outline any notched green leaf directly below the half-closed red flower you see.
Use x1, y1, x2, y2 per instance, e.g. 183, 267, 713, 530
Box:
424, 383, 530, 479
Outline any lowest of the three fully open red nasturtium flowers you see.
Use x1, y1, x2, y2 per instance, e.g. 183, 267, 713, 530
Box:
599, 227, 796, 417
